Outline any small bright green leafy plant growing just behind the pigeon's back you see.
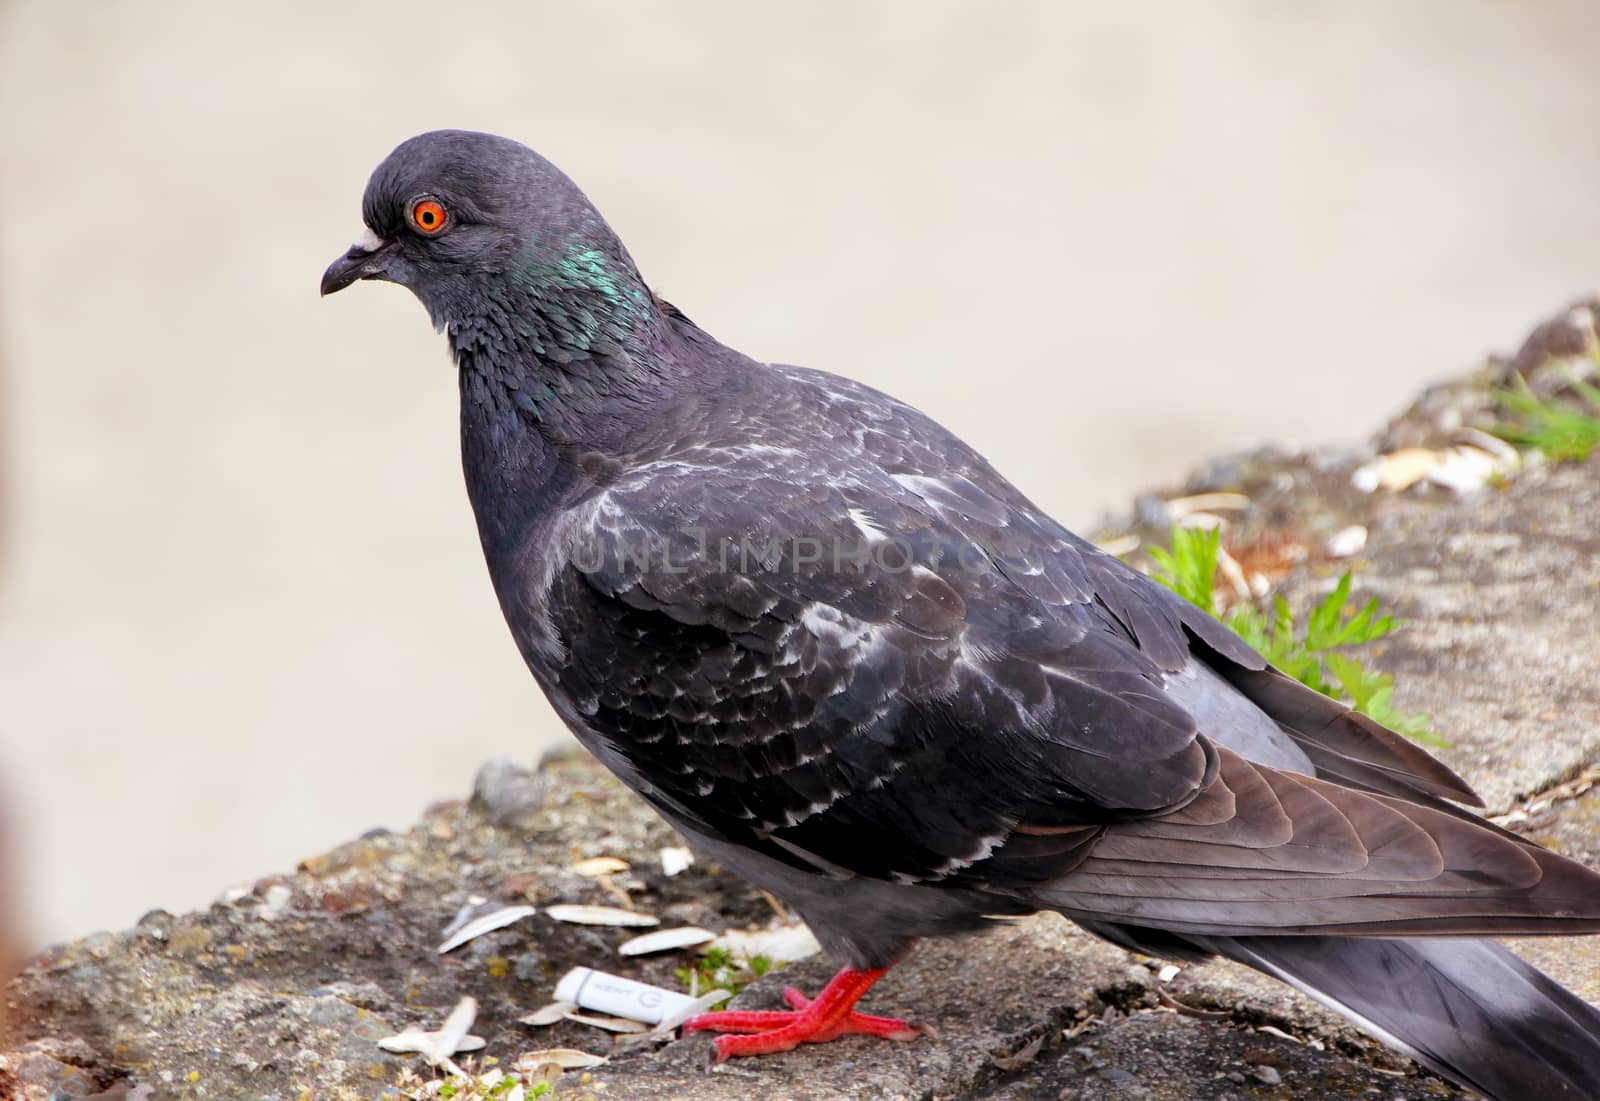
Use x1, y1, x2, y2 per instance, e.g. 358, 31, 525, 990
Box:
1150, 528, 1448, 746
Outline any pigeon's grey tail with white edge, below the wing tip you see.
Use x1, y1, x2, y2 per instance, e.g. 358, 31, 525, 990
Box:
1189, 936, 1600, 1101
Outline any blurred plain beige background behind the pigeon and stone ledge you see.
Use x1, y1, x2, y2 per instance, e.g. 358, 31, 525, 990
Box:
0, 0, 1600, 943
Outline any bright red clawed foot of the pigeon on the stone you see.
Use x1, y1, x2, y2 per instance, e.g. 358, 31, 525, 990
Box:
683, 967, 933, 1063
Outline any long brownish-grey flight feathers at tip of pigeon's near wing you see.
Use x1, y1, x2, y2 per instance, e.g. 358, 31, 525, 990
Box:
1034, 747, 1600, 936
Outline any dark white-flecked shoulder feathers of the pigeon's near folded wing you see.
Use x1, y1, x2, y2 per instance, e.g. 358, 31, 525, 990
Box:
549, 456, 1216, 880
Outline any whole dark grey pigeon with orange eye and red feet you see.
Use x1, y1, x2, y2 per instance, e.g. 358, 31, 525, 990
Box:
322, 130, 1600, 1101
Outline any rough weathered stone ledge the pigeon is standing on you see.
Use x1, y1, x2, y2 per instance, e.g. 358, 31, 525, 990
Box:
0, 318, 1600, 1101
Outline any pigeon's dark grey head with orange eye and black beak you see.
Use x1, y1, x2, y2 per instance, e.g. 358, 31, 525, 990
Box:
322, 130, 638, 326
